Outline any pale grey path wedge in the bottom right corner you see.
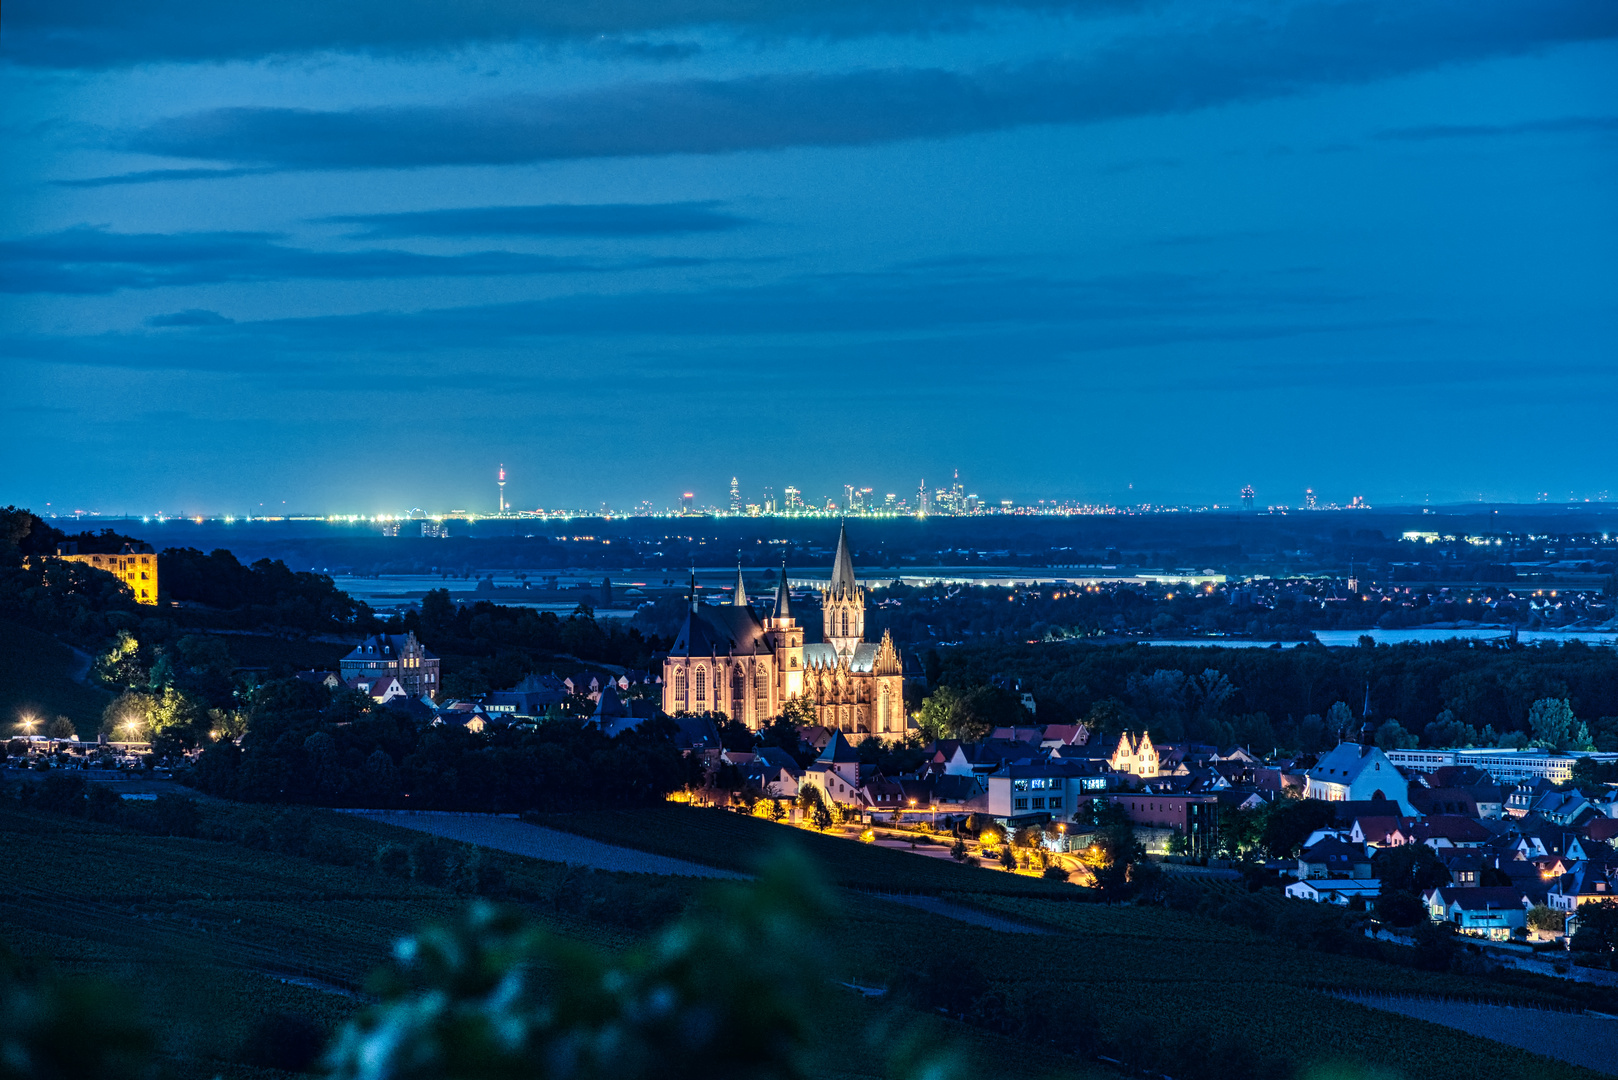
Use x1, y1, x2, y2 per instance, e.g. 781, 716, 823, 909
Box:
1335, 994, 1618, 1075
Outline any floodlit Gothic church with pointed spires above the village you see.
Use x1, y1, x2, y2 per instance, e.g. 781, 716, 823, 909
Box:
663, 529, 906, 742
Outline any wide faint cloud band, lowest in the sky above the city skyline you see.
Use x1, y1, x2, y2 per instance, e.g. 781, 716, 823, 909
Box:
9, 266, 1365, 375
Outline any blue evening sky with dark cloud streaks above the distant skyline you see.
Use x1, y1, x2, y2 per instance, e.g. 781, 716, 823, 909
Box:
0, 0, 1618, 513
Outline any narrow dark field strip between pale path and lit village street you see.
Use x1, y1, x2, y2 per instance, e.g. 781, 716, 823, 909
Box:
531, 803, 1087, 900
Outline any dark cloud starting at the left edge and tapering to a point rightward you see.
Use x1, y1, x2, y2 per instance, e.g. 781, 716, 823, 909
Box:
0, 227, 699, 293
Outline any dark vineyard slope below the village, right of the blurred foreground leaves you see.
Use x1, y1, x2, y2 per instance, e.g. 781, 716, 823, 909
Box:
544, 806, 1618, 1080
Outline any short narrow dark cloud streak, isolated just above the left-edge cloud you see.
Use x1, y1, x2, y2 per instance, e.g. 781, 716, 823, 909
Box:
317, 202, 749, 240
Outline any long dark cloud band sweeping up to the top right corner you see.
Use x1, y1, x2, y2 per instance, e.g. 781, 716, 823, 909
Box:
125, 0, 1618, 168
